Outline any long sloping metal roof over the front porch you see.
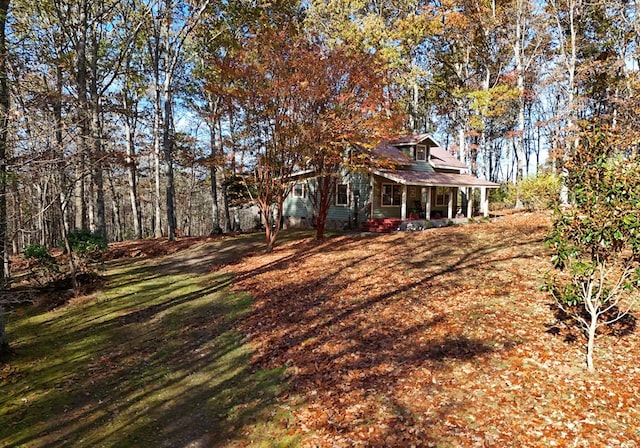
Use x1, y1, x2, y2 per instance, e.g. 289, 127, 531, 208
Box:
373, 170, 500, 188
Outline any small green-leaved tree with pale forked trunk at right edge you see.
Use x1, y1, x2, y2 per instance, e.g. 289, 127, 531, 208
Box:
546, 128, 640, 371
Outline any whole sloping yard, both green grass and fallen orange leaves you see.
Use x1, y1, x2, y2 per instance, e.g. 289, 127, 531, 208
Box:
0, 214, 640, 447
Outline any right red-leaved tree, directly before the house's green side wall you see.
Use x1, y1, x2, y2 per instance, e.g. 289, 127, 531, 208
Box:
299, 41, 398, 240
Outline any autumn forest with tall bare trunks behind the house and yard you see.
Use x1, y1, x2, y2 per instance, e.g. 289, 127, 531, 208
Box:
0, 0, 640, 274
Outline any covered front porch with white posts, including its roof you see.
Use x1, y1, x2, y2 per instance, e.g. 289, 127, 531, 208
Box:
370, 170, 500, 221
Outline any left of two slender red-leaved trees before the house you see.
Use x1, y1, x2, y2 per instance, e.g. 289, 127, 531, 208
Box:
225, 23, 305, 252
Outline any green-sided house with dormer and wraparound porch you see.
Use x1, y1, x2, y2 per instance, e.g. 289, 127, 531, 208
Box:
283, 134, 500, 231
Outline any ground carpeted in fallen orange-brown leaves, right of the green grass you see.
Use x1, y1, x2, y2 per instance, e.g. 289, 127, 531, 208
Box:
227, 214, 640, 447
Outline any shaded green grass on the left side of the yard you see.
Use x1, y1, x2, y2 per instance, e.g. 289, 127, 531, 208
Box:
0, 234, 298, 448
